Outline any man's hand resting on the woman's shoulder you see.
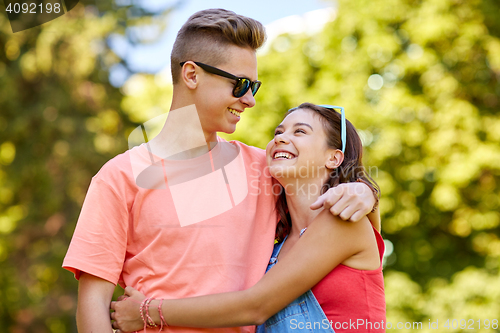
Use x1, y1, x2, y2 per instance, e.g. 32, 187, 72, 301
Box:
310, 182, 375, 222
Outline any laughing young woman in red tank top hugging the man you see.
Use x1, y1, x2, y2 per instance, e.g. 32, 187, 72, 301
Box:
111, 103, 385, 333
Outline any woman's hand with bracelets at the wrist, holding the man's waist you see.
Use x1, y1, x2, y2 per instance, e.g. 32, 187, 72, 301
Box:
111, 287, 146, 333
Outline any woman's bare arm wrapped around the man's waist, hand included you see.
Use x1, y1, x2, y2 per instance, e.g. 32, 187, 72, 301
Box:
112, 211, 376, 332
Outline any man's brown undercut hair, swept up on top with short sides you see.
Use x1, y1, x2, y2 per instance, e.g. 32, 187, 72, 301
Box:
170, 9, 266, 84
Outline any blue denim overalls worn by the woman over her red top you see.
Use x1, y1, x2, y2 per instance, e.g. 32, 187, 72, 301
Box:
256, 237, 335, 333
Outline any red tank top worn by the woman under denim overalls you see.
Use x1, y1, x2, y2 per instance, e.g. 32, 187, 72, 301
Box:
312, 228, 386, 333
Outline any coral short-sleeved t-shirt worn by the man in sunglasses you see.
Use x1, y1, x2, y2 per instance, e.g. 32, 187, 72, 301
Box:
63, 139, 277, 332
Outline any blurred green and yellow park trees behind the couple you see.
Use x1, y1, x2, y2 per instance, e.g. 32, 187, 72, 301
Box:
0, 0, 500, 333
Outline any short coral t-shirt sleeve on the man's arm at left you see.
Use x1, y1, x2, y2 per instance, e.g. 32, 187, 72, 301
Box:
63, 176, 129, 285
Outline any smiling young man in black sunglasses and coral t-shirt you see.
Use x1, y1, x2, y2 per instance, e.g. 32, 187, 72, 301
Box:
63, 9, 375, 333
